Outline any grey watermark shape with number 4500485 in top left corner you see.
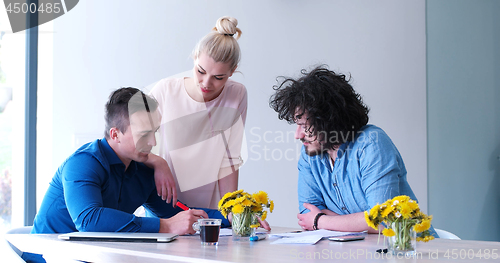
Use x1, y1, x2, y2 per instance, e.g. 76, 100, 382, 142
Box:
3, 0, 79, 33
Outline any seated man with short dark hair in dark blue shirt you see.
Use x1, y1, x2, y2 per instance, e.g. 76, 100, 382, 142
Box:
32, 88, 225, 237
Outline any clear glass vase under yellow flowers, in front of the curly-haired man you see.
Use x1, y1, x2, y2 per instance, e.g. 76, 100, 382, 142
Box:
387, 221, 417, 256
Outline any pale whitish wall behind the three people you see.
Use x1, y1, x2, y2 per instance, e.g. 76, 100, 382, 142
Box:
39, 0, 427, 227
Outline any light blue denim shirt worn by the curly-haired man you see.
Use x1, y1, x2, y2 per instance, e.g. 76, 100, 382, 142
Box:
298, 125, 417, 215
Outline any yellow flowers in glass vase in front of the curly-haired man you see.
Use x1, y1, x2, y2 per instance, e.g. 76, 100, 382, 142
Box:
365, 195, 434, 254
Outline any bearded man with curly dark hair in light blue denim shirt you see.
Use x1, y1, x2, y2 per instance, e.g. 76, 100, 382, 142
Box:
269, 66, 434, 235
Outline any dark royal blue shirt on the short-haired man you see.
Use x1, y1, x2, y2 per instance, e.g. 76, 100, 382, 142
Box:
32, 139, 229, 233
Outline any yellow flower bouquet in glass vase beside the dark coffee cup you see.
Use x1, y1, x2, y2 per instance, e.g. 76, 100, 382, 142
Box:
219, 190, 274, 239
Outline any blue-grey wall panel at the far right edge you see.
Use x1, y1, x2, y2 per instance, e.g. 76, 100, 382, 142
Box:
427, 0, 500, 241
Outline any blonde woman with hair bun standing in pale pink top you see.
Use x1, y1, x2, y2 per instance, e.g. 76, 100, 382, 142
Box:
145, 17, 247, 209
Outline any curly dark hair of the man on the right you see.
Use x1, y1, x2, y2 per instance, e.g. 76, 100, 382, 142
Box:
269, 65, 370, 149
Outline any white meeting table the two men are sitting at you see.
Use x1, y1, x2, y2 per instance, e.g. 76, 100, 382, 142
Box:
6, 227, 500, 263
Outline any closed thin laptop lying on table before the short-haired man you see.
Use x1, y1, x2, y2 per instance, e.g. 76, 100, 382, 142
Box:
58, 232, 178, 242
